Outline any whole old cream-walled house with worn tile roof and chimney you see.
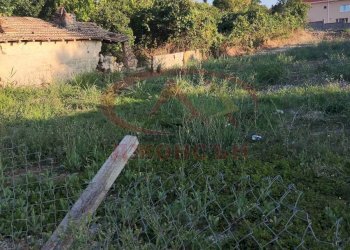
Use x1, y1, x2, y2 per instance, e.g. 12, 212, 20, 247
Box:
0, 8, 137, 86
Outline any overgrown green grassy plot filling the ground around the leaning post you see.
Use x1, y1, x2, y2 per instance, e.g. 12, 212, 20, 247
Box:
0, 42, 350, 249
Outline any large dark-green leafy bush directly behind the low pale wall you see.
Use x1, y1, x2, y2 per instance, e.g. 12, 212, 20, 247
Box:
131, 0, 219, 48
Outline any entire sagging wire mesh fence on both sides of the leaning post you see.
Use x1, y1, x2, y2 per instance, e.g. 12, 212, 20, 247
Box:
0, 139, 344, 249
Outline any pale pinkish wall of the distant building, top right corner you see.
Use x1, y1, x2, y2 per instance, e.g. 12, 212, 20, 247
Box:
309, 0, 350, 23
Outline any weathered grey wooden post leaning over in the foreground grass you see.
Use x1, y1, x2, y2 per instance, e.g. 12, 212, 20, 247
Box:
42, 135, 139, 250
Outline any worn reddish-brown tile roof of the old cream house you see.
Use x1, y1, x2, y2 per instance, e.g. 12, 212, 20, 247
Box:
0, 17, 128, 43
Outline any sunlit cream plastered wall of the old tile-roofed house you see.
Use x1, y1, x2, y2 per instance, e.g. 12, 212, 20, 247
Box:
0, 41, 102, 86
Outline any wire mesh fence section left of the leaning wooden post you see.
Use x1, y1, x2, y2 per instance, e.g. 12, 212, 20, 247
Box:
0, 138, 80, 249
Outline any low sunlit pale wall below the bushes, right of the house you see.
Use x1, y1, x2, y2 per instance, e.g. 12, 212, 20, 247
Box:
152, 50, 204, 71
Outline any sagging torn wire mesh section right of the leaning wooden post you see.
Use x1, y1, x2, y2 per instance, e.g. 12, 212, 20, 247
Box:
99, 164, 341, 249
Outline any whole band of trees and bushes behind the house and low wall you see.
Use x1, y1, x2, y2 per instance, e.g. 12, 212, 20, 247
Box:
0, 0, 308, 52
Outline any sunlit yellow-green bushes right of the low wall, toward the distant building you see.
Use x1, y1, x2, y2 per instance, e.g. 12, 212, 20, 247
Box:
218, 0, 308, 47
